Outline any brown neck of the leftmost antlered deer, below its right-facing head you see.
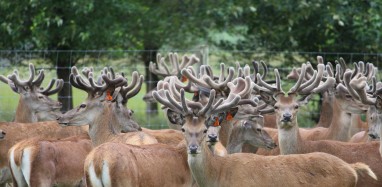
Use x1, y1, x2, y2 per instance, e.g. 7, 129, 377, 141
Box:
14, 97, 38, 123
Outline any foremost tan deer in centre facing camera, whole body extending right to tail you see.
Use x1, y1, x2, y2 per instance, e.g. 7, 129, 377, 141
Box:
154, 74, 372, 186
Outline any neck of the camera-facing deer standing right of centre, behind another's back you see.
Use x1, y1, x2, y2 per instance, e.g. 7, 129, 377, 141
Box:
277, 117, 302, 155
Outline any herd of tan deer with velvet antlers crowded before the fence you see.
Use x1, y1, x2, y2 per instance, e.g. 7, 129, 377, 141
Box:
0, 53, 382, 187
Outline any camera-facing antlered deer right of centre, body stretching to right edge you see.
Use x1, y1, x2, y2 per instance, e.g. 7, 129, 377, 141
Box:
256, 64, 382, 186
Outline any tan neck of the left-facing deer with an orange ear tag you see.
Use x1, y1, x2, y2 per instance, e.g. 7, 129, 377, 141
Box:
89, 104, 121, 146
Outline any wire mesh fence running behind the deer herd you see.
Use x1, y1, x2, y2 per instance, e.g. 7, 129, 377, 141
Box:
0, 47, 382, 128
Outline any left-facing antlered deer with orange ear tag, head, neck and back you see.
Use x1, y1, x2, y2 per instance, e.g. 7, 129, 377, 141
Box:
57, 66, 157, 146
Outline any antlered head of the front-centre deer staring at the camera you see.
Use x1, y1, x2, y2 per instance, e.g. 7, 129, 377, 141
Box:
153, 75, 251, 154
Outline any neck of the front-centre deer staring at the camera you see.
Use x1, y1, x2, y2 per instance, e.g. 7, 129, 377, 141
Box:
188, 139, 224, 187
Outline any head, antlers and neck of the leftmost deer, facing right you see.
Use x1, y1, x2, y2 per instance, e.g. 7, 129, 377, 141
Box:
0, 64, 64, 123
